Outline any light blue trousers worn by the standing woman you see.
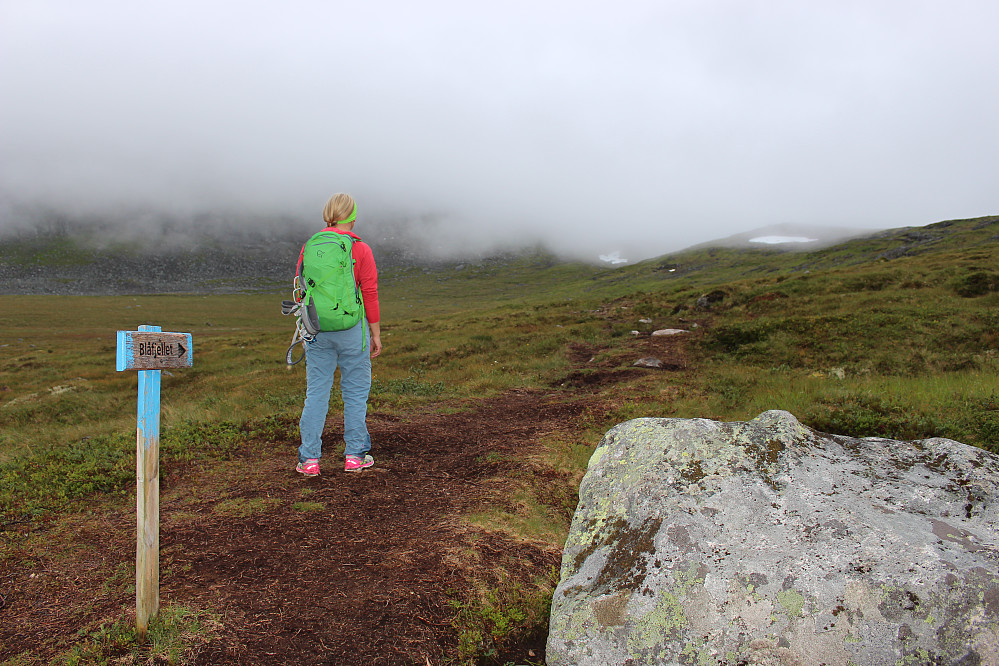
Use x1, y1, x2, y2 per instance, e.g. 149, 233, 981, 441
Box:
298, 321, 371, 462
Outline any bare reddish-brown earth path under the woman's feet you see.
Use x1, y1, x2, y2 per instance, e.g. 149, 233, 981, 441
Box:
0, 391, 583, 666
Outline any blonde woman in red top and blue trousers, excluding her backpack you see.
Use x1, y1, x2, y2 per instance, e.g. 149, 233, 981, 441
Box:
296, 193, 382, 476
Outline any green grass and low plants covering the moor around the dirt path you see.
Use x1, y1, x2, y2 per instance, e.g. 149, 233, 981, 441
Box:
0, 213, 999, 663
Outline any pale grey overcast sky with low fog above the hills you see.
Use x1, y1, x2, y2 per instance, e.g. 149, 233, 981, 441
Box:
0, 0, 999, 259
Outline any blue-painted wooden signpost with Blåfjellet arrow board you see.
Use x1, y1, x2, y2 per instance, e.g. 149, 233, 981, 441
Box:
115, 326, 194, 638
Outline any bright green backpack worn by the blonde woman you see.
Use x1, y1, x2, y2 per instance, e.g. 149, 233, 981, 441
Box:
298, 231, 364, 335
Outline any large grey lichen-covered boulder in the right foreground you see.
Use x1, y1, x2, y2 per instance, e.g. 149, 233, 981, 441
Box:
547, 411, 999, 666
